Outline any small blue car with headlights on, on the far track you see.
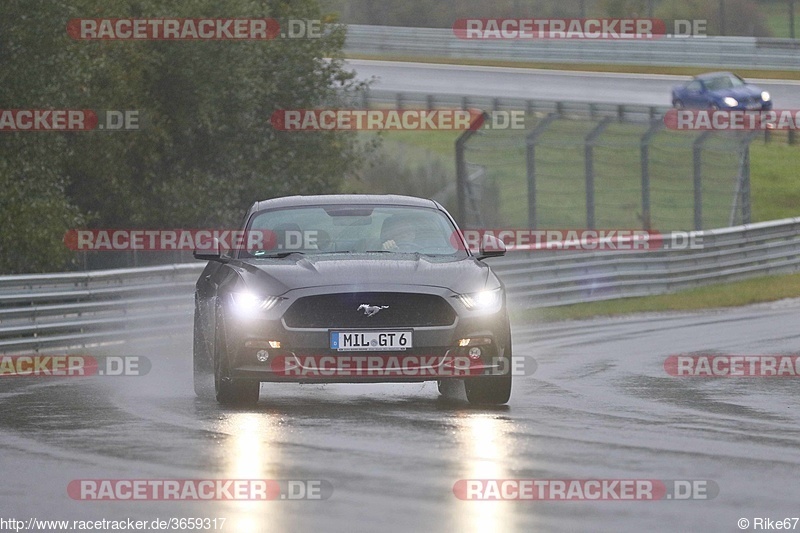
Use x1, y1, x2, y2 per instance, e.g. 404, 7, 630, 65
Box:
672, 72, 772, 110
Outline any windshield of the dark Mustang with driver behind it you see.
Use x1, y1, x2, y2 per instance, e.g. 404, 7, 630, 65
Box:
239, 205, 466, 258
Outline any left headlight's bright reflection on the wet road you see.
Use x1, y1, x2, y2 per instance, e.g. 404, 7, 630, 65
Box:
221, 413, 288, 533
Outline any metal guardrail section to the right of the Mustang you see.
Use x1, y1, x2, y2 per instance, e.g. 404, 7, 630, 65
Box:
491, 218, 800, 307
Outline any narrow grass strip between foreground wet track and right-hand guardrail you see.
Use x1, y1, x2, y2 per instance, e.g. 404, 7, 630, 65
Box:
511, 274, 800, 322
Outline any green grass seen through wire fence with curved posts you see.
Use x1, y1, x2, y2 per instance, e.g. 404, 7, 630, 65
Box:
364, 117, 800, 231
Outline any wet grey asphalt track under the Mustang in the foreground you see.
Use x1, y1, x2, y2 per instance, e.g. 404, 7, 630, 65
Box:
0, 300, 800, 533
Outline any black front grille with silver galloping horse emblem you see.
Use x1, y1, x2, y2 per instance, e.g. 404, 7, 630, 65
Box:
283, 292, 456, 328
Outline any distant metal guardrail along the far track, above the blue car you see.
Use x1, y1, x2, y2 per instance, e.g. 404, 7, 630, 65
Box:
345, 24, 800, 70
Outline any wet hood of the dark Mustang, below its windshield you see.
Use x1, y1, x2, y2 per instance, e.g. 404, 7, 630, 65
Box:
240, 254, 490, 296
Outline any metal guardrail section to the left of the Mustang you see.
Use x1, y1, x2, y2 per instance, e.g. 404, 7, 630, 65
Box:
0, 263, 204, 353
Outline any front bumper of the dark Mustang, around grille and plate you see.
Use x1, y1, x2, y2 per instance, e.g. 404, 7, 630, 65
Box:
220, 287, 510, 383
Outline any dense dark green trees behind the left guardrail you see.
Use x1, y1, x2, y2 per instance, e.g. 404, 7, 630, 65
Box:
0, 0, 366, 274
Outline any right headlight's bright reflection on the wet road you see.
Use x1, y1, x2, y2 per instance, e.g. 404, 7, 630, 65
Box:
452, 412, 524, 533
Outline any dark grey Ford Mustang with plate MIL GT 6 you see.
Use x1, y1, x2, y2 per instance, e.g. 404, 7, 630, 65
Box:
194, 195, 511, 404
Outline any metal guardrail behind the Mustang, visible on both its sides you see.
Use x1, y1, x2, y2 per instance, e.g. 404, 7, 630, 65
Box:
0, 217, 800, 353
